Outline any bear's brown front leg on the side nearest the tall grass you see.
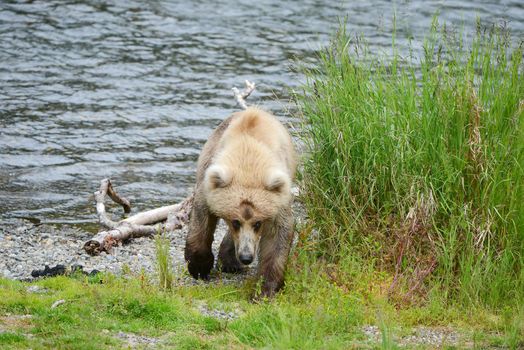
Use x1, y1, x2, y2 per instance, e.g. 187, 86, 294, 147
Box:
258, 207, 293, 298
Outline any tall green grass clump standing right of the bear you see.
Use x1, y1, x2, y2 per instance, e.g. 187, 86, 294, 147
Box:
298, 20, 524, 306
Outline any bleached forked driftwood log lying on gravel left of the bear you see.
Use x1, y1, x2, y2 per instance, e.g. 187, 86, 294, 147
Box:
84, 179, 193, 255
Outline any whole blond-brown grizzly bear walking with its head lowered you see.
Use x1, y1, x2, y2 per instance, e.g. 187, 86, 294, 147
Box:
185, 107, 296, 297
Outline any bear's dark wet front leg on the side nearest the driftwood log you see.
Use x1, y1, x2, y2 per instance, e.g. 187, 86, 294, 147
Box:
184, 197, 218, 279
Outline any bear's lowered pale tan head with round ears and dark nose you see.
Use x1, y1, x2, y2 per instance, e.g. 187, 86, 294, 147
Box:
204, 165, 292, 265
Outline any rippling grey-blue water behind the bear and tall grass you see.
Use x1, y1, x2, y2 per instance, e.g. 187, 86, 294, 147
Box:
0, 0, 524, 230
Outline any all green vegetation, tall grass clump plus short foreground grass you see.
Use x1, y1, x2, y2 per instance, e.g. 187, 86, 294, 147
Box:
0, 18, 524, 349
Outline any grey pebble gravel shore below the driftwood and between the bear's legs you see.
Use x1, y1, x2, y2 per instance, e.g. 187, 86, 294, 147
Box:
0, 216, 250, 284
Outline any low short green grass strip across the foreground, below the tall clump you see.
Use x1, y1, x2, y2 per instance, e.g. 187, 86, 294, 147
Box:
0, 264, 523, 349
